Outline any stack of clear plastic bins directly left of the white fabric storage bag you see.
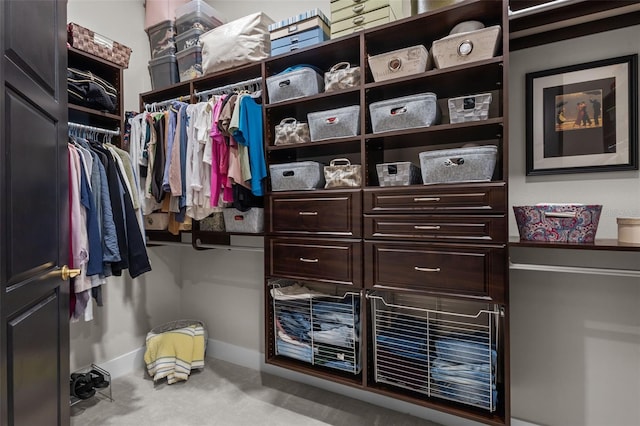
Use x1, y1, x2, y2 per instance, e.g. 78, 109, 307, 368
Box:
176, 0, 225, 81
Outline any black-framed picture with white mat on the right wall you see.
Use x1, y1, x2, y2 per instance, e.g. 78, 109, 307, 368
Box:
526, 55, 638, 176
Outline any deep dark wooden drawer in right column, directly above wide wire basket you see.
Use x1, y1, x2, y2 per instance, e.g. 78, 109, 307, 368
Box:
364, 241, 508, 303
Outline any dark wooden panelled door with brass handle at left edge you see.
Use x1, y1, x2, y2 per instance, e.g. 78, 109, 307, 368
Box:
0, 0, 69, 426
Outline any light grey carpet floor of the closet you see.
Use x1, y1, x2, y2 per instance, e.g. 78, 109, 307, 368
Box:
71, 358, 438, 426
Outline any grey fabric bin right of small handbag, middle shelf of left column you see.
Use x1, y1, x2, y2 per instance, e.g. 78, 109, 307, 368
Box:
307, 105, 360, 141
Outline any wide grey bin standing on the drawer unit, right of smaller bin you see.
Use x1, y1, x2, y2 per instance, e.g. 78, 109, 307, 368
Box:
419, 145, 498, 184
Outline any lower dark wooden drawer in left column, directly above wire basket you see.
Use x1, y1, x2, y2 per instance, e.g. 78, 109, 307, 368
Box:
265, 238, 362, 287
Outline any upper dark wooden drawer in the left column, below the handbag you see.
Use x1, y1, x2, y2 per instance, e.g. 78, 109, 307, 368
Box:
266, 189, 362, 238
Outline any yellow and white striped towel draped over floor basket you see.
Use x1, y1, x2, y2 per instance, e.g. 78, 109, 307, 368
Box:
144, 325, 205, 384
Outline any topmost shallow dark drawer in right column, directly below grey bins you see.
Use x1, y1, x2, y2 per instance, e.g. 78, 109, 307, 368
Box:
364, 182, 506, 213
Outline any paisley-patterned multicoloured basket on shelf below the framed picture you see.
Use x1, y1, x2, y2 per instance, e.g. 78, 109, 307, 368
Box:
513, 204, 602, 243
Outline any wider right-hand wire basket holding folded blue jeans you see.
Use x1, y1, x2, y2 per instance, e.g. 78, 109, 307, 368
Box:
367, 294, 500, 412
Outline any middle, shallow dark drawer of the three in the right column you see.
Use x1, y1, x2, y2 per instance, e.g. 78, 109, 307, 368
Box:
364, 215, 507, 243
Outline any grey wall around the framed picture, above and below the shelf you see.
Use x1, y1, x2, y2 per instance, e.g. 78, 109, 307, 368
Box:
509, 26, 640, 426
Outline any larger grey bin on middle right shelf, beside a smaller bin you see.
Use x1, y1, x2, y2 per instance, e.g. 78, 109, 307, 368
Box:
369, 93, 440, 133
